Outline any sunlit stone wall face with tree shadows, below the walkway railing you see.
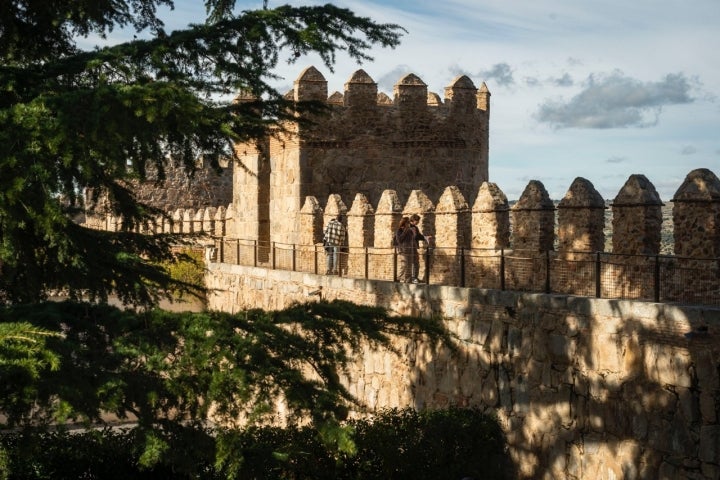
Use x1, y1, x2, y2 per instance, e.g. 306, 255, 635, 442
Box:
202, 263, 720, 480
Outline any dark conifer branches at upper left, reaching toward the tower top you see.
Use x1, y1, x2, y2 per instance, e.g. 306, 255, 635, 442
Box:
0, 0, 402, 305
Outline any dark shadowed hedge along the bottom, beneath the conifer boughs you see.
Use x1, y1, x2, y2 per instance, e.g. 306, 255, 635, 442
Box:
0, 408, 514, 480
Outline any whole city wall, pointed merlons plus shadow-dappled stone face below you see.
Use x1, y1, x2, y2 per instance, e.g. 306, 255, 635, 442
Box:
84, 162, 720, 479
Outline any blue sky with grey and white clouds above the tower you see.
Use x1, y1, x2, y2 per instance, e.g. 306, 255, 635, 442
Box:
95, 0, 720, 202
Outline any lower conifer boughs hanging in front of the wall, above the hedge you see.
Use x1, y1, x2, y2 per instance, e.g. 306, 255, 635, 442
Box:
0, 301, 452, 472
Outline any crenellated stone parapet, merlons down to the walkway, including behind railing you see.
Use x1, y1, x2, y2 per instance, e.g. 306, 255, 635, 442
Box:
81, 169, 720, 303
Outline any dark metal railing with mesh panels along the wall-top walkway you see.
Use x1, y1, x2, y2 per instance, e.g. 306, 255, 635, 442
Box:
213, 237, 720, 305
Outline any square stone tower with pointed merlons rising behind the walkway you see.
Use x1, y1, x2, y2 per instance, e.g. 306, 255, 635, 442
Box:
229, 67, 490, 243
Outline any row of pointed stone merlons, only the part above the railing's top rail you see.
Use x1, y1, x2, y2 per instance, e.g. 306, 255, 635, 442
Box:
86, 169, 720, 258
